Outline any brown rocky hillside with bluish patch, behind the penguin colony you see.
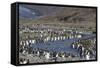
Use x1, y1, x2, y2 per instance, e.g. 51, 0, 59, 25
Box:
19, 5, 96, 27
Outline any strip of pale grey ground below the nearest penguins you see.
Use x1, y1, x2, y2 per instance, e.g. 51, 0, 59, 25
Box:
19, 53, 95, 63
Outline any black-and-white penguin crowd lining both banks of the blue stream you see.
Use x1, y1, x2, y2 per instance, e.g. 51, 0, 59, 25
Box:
19, 27, 96, 64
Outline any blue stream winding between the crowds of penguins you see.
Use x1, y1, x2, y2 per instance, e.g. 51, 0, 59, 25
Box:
33, 34, 96, 55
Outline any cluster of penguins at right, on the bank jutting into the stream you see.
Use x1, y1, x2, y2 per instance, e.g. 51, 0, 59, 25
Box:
71, 39, 96, 60
